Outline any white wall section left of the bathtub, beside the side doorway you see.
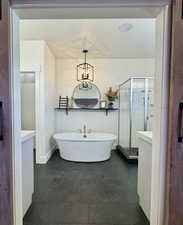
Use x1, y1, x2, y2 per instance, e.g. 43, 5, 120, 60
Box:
20, 41, 55, 163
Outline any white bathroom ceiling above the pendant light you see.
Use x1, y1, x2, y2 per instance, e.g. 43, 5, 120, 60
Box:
20, 19, 155, 58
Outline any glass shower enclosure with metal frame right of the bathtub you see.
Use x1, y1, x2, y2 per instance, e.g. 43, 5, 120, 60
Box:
118, 77, 153, 159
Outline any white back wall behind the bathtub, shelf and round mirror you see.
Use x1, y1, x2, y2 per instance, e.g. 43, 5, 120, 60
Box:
56, 59, 154, 144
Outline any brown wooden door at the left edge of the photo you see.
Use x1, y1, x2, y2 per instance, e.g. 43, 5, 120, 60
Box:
0, 0, 13, 225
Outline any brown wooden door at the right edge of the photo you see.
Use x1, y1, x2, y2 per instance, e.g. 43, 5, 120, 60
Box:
165, 0, 183, 225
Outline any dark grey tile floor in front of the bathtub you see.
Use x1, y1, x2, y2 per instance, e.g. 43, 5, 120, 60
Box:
24, 151, 149, 225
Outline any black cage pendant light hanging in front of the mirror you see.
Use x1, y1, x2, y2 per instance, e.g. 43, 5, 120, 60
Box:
77, 49, 94, 87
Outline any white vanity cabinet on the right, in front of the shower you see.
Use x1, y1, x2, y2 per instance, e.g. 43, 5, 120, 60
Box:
137, 131, 152, 220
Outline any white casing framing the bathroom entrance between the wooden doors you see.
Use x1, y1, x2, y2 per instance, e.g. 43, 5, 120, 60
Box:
11, 0, 171, 225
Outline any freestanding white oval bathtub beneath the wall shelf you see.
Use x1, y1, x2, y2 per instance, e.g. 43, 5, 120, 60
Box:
53, 133, 116, 162
